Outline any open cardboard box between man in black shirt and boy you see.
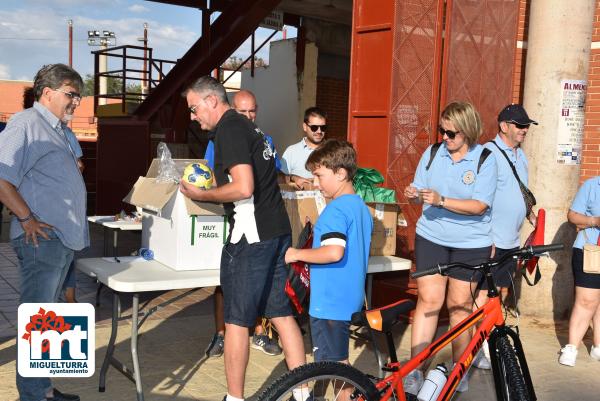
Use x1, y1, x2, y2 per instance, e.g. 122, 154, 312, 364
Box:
279, 184, 325, 247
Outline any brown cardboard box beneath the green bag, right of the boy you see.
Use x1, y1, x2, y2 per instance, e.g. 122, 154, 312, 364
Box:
367, 202, 399, 256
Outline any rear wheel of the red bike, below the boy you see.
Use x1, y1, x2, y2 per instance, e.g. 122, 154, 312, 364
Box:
258, 362, 378, 401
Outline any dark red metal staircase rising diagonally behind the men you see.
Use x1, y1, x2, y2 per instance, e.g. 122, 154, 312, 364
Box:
95, 0, 281, 214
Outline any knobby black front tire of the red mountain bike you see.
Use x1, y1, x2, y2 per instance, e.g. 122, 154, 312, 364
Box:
497, 336, 531, 401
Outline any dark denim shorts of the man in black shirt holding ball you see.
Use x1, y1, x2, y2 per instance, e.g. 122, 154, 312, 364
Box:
221, 234, 292, 327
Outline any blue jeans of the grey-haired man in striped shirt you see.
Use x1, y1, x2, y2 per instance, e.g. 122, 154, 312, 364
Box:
11, 230, 74, 401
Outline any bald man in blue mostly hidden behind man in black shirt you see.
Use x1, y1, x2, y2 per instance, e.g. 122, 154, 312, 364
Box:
204, 89, 282, 357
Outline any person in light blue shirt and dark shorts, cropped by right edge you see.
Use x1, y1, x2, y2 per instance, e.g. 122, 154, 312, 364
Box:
558, 176, 600, 366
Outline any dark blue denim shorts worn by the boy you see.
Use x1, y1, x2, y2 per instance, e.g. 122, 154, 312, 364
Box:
310, 316, 350, 362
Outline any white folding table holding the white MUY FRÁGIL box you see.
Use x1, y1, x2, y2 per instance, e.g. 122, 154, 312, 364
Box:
76, 256, 411, 401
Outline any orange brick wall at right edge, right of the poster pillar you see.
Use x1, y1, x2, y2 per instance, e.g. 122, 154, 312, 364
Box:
579, 3, 600, 182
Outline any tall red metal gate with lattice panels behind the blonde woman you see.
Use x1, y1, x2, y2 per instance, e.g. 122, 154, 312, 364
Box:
348, 0, 519, 257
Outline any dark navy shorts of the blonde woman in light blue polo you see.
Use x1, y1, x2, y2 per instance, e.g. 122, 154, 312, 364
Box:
415, 234, 492, 282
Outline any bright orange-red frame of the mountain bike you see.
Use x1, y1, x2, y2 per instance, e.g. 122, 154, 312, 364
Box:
376, 295, 506, 401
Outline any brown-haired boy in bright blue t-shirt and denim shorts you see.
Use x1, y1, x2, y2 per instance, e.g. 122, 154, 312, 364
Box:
285, 139, 373, 363
